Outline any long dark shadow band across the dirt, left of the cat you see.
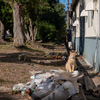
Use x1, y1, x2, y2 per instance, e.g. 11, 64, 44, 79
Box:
0, 52, 65, 67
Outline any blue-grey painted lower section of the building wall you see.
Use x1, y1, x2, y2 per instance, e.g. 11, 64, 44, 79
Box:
76, 37, 100, 71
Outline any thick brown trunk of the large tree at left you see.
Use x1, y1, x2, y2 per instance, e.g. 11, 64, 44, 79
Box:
13, 1, 24, 46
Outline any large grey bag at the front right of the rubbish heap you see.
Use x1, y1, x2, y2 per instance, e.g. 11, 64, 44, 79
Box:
41, 81, 77, 100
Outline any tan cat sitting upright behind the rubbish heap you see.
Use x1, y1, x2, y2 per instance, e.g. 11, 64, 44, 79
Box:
65, 51, 77, 73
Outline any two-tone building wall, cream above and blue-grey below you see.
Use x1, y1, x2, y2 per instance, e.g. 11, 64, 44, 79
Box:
71, 0, 100, 71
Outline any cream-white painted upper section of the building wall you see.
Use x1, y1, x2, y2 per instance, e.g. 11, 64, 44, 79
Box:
76, 0, 100, 37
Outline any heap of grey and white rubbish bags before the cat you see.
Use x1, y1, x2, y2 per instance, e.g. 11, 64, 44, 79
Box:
12, 70, 79, 100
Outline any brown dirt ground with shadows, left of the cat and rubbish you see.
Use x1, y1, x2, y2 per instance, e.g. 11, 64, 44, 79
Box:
0, 42, 66, 100
